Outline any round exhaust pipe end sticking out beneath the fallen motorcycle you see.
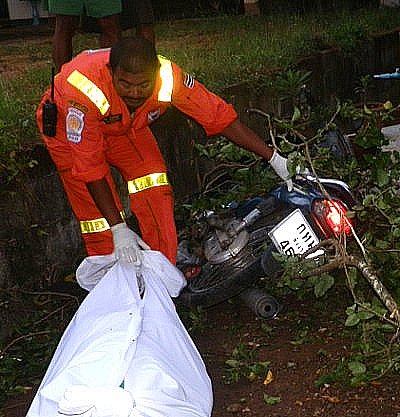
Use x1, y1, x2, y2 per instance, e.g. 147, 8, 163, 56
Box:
240, 288, 281, 320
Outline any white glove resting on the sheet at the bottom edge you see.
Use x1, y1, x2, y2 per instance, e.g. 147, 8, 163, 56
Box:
58, 385, 135, 417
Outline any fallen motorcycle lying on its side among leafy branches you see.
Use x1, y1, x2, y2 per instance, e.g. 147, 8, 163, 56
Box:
177, 174, 355, 319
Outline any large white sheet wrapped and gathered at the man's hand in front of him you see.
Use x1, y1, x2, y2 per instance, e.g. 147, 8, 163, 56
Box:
27, 251, 213, 417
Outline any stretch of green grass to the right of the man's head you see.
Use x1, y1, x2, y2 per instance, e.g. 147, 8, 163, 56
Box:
157, 9, 400, 91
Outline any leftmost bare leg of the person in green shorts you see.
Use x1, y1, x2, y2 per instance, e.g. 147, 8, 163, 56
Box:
53, 15, 79, 71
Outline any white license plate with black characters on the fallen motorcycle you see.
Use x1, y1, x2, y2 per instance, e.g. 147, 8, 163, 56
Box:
269, 209, 323, 257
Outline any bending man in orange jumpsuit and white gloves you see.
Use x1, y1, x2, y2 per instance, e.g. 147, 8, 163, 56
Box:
37, 38, 291, 265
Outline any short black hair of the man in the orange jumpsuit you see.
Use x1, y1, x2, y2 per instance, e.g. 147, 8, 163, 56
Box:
110, 37, 159, 74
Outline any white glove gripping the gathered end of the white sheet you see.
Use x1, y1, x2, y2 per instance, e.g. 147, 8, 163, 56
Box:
111, 223, 150, 266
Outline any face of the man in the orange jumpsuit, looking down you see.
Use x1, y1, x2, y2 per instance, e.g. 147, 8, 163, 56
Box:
112, 68, 156, 112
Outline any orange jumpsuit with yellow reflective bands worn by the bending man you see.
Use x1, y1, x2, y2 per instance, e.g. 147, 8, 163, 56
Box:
37, 50, 237, 263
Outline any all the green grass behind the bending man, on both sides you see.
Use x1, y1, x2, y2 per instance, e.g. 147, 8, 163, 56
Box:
0, 9, 400, 164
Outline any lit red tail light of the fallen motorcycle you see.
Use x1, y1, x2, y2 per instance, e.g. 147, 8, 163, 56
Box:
312, 200, 351, 236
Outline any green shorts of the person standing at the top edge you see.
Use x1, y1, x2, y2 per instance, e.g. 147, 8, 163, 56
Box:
44, 0, 122, 19
